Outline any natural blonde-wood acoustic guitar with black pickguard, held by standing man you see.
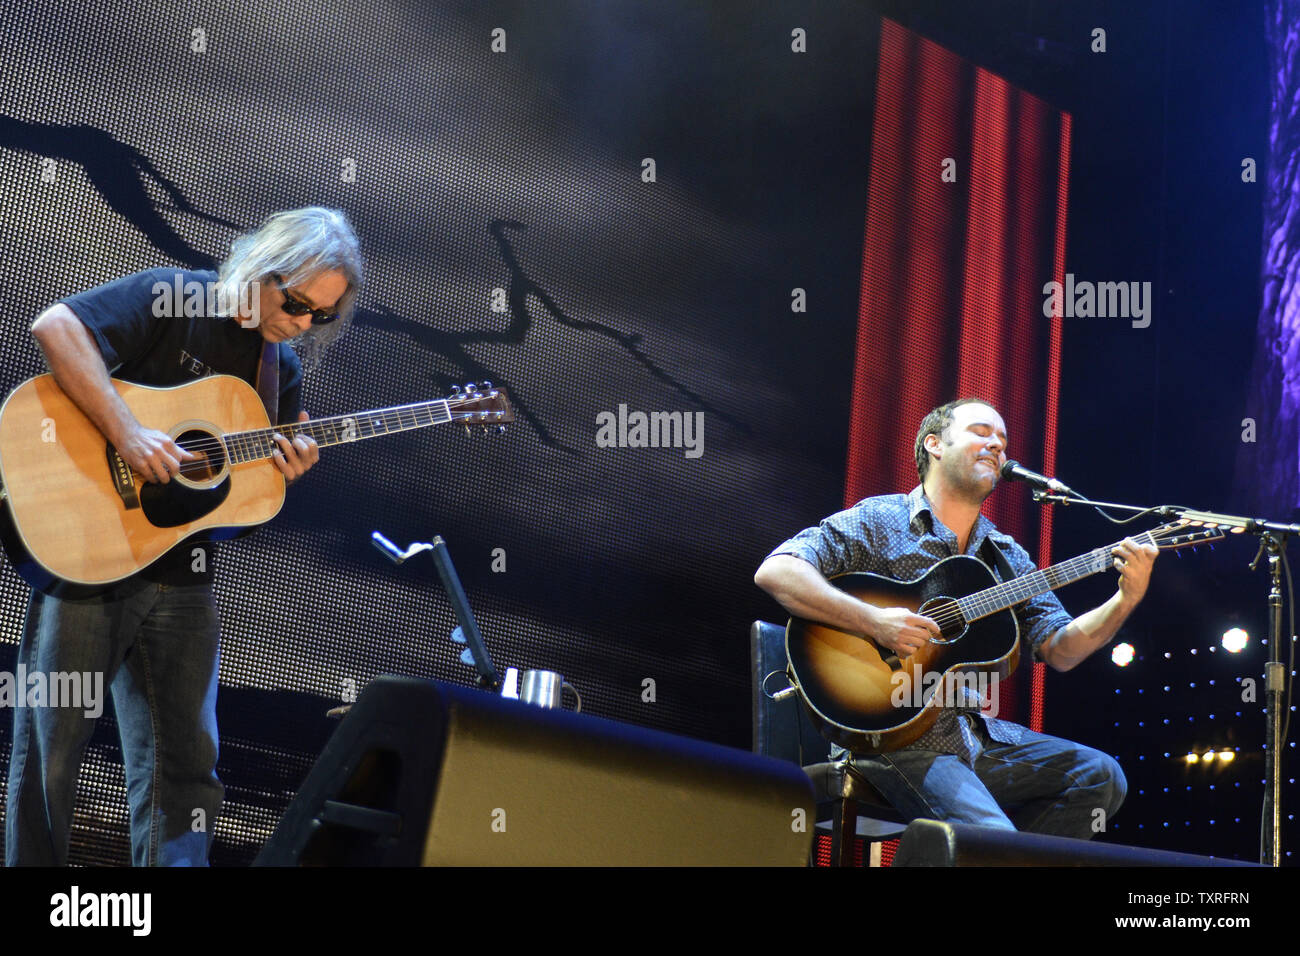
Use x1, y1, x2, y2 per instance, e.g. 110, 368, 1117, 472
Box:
0, 375, 515, 597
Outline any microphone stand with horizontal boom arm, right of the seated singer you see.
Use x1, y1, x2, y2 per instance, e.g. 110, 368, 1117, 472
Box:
1034, 489, 1300, 866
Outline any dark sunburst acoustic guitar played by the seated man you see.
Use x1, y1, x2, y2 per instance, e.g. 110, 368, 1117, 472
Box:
785, 522, 1223, 753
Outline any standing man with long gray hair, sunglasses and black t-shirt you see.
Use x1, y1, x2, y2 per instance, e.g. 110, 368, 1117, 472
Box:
5, 207, 361, 866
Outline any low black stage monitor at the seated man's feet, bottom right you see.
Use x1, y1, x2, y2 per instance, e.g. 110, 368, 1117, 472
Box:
893, 819, 1258, 866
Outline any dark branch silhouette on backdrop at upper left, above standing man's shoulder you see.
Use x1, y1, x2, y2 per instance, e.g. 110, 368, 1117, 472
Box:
0, 116, 238, 269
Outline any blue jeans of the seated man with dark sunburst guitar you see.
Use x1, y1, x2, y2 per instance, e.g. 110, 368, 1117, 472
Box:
853, 717, 1128, 840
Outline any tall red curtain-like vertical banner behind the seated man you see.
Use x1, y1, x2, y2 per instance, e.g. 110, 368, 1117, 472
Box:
845, 20, 1070, 728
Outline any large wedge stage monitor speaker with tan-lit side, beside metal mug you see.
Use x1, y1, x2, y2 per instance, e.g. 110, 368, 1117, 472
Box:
255, 676, 815, 866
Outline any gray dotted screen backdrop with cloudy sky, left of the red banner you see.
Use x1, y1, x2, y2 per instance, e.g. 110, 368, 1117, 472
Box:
0, 0, 879, 864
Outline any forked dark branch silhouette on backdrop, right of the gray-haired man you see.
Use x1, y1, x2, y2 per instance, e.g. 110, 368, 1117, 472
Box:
355, 219, 751, 454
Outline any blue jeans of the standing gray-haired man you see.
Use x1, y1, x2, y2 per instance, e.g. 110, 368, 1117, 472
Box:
5, 583, 224, 866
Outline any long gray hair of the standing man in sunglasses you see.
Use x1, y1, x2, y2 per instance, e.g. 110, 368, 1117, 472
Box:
217, 206, 361, 368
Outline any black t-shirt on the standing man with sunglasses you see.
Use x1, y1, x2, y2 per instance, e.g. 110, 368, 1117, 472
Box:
62, 268, 303, 584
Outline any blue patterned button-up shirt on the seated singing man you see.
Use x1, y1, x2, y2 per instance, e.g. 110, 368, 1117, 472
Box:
768, 485, 1073, 765
